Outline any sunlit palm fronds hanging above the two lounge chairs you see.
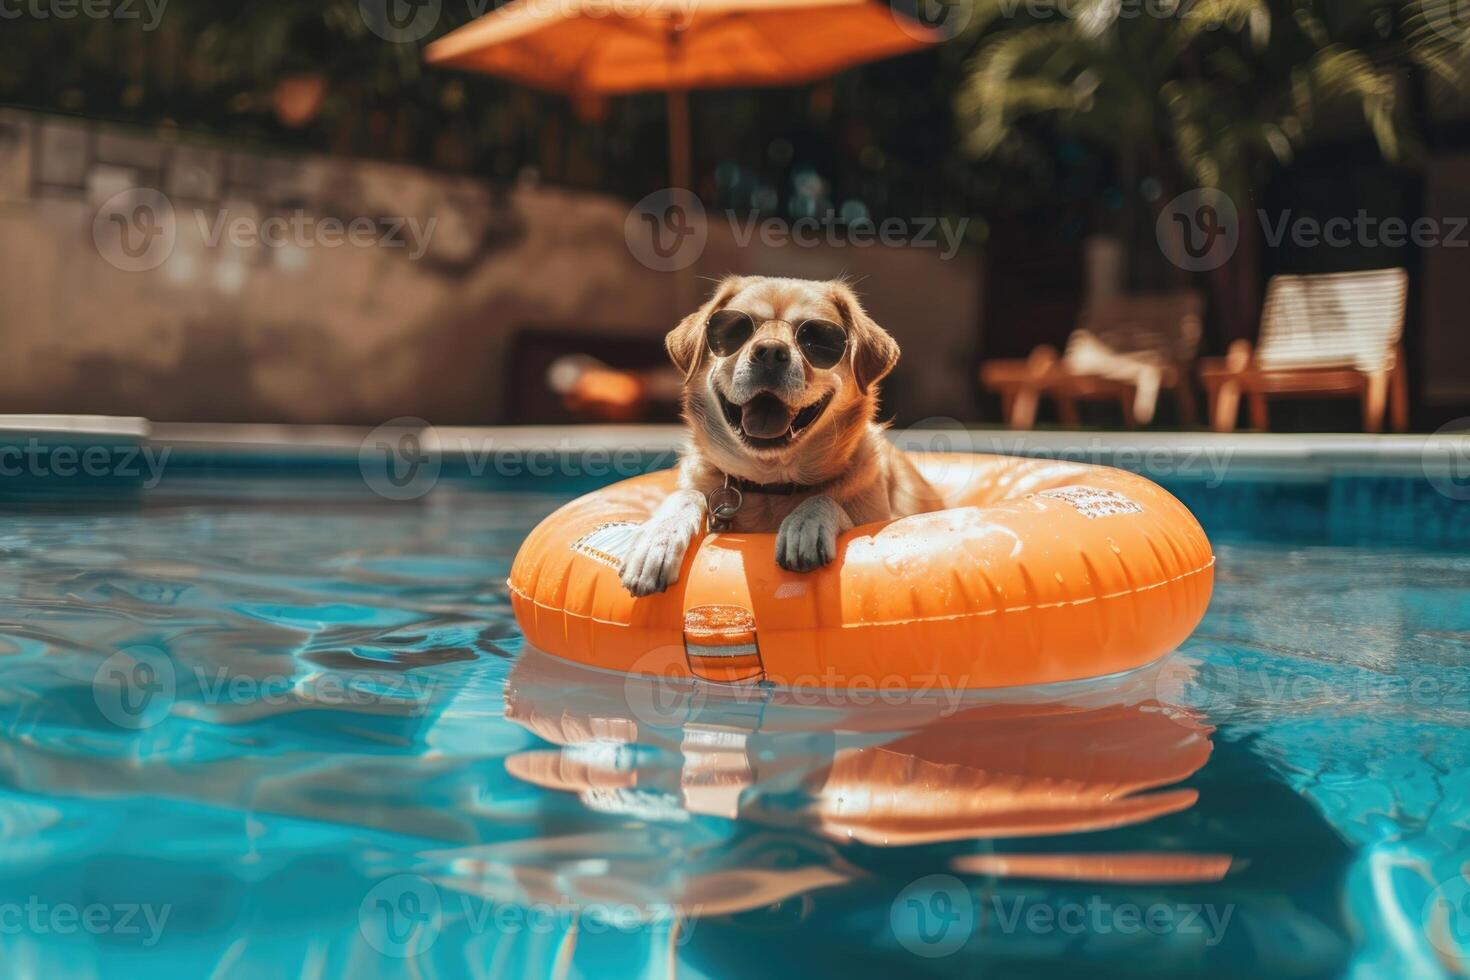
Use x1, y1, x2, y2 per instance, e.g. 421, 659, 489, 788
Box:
957, 0, 1470, 200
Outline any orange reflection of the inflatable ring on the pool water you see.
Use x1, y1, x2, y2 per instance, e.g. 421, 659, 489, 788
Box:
506, 652, 1230, 882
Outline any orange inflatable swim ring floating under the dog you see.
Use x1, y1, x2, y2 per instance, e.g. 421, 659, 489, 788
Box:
509, 454, 1214, 691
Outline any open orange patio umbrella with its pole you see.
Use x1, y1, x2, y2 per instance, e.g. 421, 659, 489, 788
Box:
425, 0, 942, 188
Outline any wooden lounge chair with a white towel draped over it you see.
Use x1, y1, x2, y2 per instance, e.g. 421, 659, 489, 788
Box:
980, 292, 1204, 429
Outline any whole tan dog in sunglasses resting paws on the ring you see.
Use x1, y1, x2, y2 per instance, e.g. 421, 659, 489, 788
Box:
622, 276, 944, 595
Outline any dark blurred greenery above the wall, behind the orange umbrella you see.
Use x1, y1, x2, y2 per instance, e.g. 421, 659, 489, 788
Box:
0, 0, 1470, 255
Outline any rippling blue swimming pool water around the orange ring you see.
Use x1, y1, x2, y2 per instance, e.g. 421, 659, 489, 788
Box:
0, 426, 1470, 979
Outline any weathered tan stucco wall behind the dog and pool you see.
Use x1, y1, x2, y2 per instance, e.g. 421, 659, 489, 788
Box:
0, 110, 980, 423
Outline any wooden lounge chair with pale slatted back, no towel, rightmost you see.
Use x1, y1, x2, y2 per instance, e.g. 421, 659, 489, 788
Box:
1200, 269, 1408, 432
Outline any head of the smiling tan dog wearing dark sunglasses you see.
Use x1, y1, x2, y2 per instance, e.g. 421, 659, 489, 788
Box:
666, 276, 898, 482
